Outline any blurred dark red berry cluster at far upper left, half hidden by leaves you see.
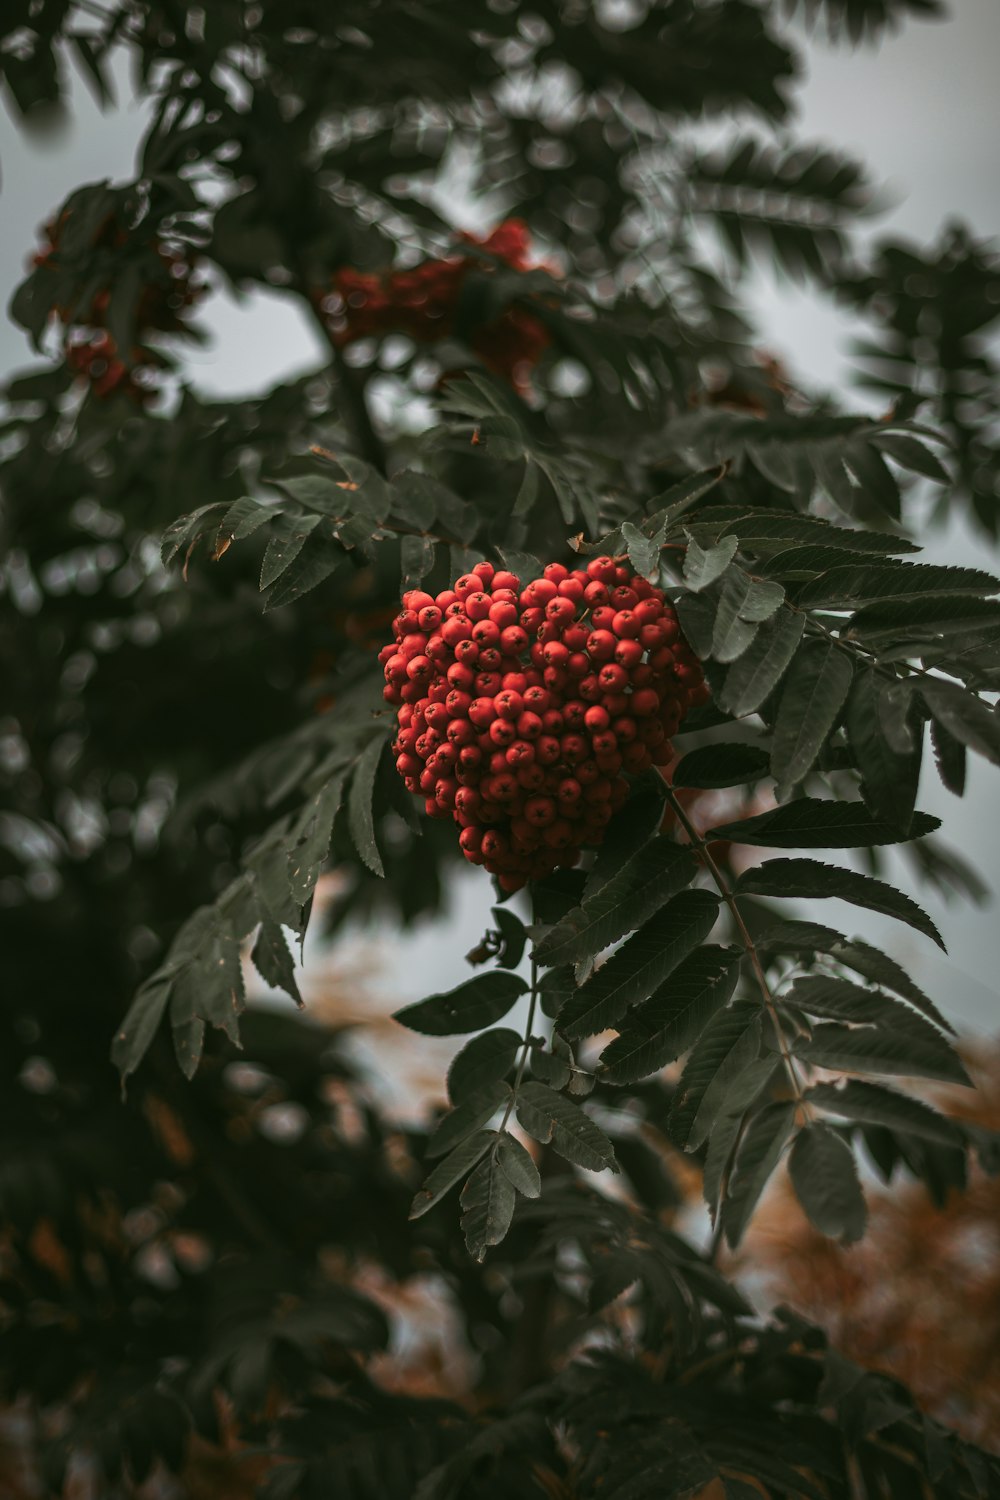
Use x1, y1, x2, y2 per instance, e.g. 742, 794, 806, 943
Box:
33, 213, 207, 404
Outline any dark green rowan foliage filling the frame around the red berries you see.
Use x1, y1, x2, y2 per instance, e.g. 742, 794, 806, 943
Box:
0, 0, 1000, 1500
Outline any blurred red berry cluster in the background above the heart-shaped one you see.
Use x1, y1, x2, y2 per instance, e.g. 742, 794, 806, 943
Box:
324, 219, 549, 390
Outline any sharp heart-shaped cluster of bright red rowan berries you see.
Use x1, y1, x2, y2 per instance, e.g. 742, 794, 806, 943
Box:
379, 557, 708, 891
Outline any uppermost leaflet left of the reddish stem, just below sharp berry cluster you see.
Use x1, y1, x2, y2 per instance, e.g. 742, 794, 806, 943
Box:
534, 839, 697, 965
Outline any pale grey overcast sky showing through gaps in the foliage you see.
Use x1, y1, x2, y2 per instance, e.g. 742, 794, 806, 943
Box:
0, 0, 1000, 1050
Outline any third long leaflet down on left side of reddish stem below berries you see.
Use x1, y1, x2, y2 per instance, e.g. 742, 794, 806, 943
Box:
601, 947, 739, 1085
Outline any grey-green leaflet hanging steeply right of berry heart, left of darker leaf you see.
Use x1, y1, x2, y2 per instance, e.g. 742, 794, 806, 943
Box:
771, 641, 855, 789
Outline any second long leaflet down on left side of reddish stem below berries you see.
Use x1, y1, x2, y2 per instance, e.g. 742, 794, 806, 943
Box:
558, 890, 720, 1040
